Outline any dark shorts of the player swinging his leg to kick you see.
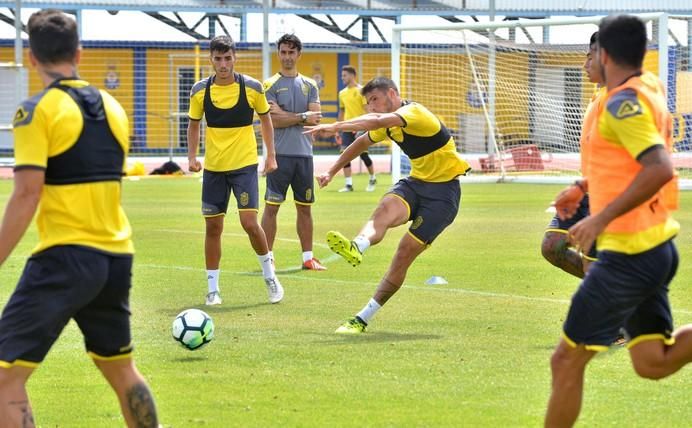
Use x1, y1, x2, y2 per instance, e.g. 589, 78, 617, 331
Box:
387, 177, 461, 245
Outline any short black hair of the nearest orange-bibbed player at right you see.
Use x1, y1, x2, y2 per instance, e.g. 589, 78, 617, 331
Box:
598, 15, 647, 68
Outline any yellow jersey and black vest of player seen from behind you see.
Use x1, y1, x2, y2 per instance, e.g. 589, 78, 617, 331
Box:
14, 79, 134, 254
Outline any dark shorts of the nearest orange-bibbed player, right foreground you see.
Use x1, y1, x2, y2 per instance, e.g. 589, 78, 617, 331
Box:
564, 241, 678, 351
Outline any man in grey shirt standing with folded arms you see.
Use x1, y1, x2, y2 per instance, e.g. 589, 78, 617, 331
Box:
262, 34, 327, 270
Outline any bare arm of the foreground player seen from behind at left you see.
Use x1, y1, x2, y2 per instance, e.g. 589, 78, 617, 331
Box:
0, 169, 45, 265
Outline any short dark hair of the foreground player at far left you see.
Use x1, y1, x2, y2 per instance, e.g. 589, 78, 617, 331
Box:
27, 9, 79, 64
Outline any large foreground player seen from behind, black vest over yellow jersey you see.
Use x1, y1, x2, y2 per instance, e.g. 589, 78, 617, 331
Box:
0, 10, 158, 427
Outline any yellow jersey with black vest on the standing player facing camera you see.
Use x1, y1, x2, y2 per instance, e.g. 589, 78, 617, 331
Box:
188, 73, 269, 172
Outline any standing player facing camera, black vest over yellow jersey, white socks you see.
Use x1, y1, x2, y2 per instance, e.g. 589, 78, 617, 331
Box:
187, 36, 284, 305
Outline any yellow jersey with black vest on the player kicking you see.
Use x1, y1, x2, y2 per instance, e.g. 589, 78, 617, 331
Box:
368, 102, 471, 183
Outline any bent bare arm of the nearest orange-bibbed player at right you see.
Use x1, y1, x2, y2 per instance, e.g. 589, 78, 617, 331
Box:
569, 145, 673, 251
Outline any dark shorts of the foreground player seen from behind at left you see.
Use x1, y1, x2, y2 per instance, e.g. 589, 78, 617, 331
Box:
0, 245, 132, 367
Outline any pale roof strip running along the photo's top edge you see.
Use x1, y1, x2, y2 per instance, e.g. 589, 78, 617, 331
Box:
0, 0, 692, 16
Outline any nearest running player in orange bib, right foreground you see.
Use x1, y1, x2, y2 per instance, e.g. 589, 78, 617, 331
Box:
545, 15, 692, 427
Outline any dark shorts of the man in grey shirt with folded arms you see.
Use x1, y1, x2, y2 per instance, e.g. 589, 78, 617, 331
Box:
264, 155, 315, 205
